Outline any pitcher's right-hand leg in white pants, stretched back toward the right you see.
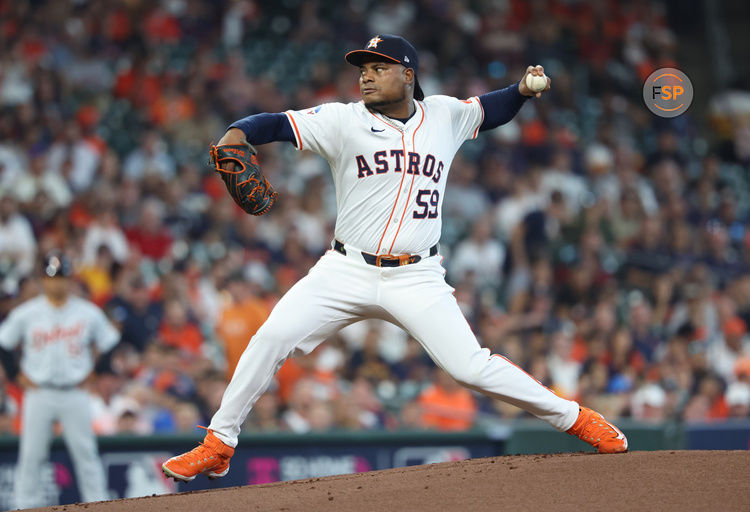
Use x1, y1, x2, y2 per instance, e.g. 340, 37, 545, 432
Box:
383, 264, 578, 431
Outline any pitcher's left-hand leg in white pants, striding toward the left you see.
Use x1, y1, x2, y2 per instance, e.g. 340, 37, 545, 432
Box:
209, 256, 374, 447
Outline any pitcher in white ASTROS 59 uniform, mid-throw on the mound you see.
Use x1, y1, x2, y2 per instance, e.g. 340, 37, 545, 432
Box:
162, 35, 627, 482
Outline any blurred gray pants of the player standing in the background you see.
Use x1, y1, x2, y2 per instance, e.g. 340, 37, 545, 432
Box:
14, 389, 109, 508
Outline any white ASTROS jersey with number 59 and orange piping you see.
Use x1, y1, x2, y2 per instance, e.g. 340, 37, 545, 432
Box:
286, 96, 484, 254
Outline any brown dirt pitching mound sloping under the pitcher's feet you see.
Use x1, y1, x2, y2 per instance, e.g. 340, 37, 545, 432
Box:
30, 451, 750, 512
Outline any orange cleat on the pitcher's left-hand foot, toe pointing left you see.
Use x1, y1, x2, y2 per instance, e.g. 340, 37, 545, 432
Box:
161, 427, 234, 482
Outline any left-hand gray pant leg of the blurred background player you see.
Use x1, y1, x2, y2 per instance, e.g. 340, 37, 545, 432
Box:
14, 389, 54, 509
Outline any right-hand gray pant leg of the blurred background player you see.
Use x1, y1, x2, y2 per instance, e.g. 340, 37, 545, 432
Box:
60, 390, 109, 501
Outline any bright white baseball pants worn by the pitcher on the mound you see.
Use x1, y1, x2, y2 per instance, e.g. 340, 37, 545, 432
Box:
209, 250, 578, 447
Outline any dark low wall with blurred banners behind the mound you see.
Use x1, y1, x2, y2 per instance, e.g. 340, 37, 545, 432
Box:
0, 420, 750, 510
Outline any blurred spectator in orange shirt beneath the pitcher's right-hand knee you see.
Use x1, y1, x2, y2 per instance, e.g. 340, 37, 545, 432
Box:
417, 369, 477, 430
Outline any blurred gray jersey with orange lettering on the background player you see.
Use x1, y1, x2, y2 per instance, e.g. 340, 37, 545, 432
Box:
0, 295, 120, 387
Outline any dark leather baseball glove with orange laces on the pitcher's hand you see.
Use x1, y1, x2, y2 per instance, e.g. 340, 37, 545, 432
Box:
209, 144, 276, 215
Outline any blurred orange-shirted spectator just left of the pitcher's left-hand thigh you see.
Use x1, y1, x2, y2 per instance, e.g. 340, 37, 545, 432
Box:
216, 274, 269, 379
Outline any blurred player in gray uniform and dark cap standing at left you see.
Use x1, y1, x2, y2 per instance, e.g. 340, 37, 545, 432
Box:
0, 252, 120, 508
